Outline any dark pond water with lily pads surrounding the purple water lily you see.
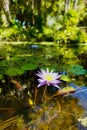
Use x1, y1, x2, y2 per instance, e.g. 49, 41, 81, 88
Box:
0, 42, 87, 130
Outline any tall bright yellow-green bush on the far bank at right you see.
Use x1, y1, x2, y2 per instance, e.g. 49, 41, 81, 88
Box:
54, 9, 87, 43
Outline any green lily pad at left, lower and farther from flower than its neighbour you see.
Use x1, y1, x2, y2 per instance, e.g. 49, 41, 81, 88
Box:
5, 68, 24, 76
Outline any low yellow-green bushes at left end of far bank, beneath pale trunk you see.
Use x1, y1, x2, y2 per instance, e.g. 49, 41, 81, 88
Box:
0, 25, 26, 41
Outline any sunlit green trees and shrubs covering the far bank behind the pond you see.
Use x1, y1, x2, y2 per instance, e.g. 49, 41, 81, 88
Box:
0, 0, 87, 44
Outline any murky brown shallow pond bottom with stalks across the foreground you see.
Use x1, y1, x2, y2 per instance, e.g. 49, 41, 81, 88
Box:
0, 92, 86, 130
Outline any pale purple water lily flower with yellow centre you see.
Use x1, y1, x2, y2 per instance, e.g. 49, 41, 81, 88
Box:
36, 68, 61, 89
